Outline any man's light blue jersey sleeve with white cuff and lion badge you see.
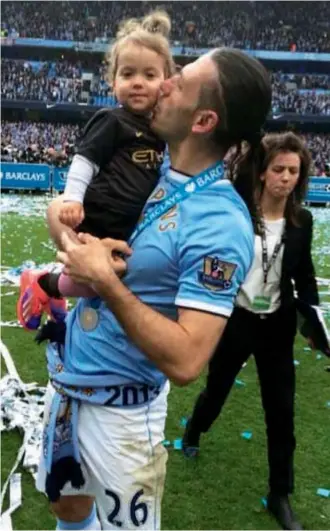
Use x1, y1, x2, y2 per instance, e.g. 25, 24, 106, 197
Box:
175, 203, 254, 317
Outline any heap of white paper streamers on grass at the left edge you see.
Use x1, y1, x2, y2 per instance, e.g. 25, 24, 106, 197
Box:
0, 340, 46, 529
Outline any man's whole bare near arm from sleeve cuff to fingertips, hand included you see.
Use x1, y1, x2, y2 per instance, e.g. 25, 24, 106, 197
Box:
57, 234, 227, 385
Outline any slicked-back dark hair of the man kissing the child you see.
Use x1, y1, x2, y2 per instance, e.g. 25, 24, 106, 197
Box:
201, 48, 272, 224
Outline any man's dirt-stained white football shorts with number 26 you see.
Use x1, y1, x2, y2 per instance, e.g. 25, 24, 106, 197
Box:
37, 382, 170, 530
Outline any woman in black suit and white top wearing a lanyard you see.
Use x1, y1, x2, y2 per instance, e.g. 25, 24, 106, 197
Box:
183, 133, 319, 529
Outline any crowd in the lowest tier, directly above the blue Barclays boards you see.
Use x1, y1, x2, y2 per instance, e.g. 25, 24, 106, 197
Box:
1, 122, 330, 176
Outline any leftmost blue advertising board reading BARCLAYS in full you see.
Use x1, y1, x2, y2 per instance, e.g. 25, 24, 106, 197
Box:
1, 162, 51, 190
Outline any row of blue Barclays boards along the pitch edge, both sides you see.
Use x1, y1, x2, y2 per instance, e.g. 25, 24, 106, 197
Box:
1, 162, 330, 204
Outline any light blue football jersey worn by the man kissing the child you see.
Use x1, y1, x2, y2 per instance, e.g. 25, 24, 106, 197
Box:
65, 169, 254, 385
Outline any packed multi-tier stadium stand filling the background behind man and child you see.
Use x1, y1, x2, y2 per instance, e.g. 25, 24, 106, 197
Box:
1, 1, 330, 176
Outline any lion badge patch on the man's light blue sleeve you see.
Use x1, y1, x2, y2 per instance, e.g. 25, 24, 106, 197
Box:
198, 256, 237, 291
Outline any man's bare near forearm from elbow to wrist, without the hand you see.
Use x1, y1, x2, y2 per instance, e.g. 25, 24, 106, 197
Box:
95, 277, 198, 385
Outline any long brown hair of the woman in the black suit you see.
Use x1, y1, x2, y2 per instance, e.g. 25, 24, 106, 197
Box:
255, 132, 312, 226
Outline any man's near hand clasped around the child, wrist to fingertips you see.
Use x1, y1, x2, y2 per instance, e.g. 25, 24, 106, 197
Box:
57, 233, 132, 287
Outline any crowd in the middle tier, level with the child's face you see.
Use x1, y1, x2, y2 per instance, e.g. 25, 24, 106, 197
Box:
1, 59, 330, 116
